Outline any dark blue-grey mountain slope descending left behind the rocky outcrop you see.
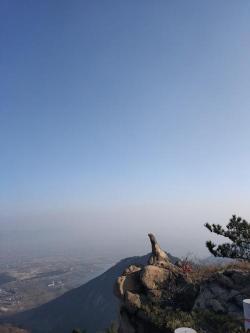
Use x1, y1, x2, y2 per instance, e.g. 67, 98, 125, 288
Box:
4, 255, 177, 333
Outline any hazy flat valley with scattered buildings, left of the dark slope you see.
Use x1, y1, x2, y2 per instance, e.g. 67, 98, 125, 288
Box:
0, 256, 111, 318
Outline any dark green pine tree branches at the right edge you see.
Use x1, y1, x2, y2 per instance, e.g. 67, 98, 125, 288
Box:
205, 215, 250, 261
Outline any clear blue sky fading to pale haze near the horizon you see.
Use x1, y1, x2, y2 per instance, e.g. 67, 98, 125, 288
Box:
0, 0, 250, 252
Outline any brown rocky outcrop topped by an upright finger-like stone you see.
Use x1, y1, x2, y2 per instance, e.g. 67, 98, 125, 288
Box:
115, 234, 250, 333
